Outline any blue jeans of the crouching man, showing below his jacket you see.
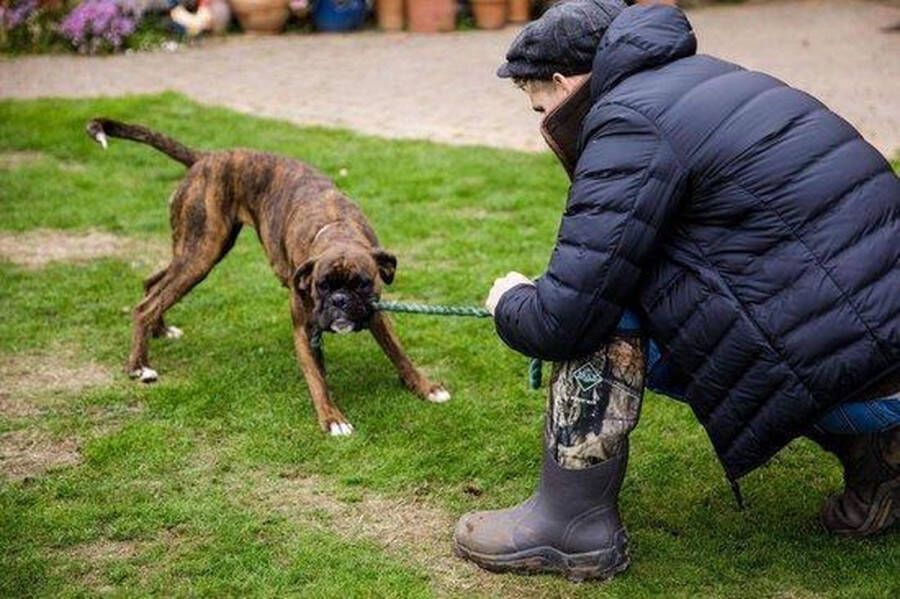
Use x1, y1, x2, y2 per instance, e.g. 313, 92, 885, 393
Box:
618, 310, 900, 435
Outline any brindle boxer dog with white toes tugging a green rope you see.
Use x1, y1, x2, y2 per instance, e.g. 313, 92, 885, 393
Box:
87, 119, 450, 435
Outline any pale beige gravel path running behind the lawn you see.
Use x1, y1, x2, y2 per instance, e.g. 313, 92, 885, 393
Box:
0, 0, 900, 155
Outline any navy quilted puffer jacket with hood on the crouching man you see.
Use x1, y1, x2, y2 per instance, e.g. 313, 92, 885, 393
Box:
496, 5, 900, 479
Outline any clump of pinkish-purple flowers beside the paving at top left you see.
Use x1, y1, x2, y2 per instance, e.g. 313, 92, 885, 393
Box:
59, 0, 141, 54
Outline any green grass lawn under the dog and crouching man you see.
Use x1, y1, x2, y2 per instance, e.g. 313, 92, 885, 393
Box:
0, 94, 900, 597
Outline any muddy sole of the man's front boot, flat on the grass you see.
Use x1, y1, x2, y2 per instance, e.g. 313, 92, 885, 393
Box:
453, 541, 631, 582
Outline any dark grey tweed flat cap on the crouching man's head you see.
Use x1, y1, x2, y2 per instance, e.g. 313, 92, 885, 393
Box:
497, 0, 627, 79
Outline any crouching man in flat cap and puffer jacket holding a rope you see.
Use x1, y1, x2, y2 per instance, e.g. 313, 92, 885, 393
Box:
454, 0, 900, 579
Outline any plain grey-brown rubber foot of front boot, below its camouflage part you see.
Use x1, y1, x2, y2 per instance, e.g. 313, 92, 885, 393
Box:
453, 449, 629, 581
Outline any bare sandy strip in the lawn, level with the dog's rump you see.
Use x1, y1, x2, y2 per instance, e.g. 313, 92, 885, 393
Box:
0, 229, 167, 269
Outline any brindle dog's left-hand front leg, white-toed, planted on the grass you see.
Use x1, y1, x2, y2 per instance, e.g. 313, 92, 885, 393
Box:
291, 294, 353, 436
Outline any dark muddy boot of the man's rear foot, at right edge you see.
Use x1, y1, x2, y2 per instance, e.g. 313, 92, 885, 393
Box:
821, 428, 900, 537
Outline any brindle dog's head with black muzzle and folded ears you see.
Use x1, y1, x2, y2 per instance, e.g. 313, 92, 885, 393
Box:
294, 247, 397, 333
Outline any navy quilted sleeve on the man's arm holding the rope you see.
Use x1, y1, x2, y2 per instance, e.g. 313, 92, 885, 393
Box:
494, 105, 686, 361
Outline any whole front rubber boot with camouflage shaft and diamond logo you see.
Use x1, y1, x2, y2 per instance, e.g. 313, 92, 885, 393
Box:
453, 334, 644, 580
